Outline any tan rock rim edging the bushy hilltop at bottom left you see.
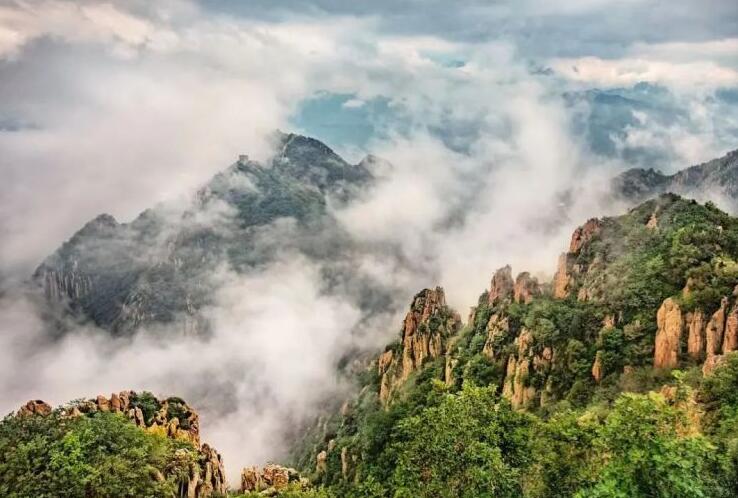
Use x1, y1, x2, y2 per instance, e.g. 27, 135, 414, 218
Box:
18, 391, 223, 498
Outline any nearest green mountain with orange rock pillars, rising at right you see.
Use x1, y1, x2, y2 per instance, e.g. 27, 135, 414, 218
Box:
280, 194, 738, 497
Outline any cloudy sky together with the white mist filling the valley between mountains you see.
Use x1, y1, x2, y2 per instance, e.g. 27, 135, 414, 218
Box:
0, 0, 738, 484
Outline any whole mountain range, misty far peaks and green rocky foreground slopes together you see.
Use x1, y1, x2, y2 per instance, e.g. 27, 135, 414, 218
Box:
0, 134, 738, 498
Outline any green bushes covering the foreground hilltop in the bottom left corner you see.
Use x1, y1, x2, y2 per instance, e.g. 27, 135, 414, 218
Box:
0, 410, 196, 498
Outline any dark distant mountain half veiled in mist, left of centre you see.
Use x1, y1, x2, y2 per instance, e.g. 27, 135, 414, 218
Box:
34, 133, 376, 334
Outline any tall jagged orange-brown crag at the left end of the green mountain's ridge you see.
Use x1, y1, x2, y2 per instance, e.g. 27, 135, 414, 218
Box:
377, 288, 458, 403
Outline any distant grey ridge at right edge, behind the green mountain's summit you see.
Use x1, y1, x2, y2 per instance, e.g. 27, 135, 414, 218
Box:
613, 150, 738, 212
